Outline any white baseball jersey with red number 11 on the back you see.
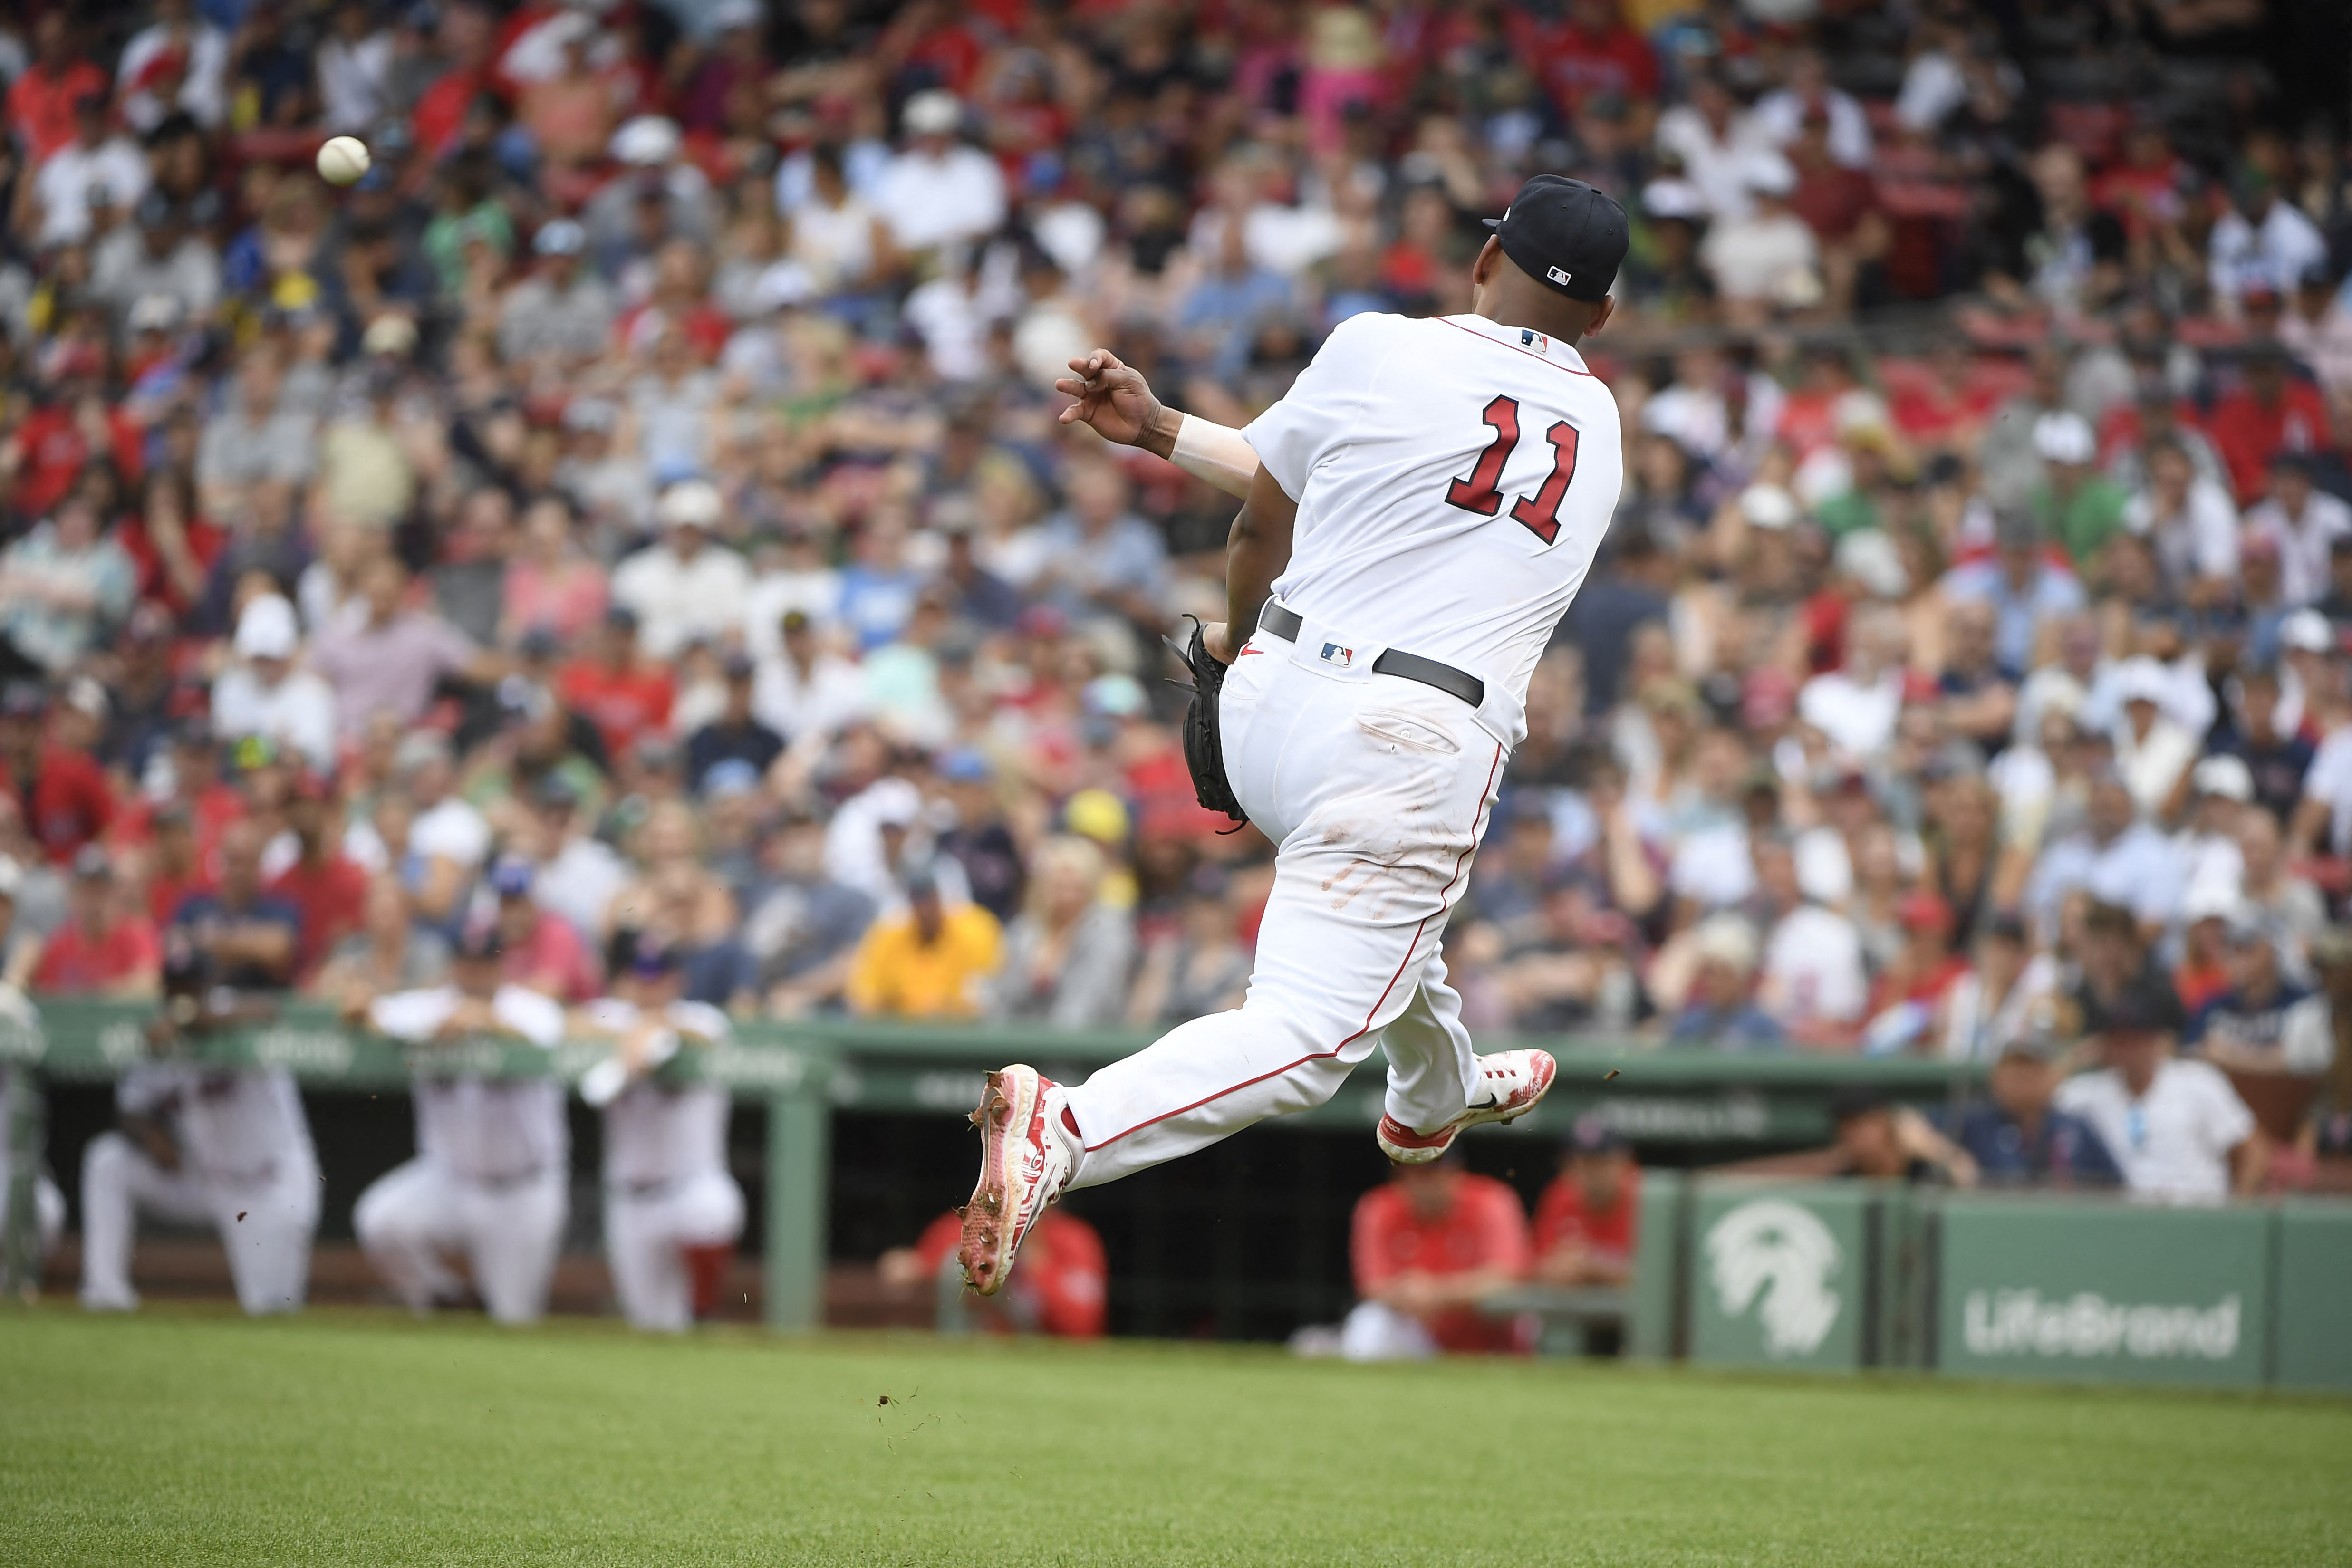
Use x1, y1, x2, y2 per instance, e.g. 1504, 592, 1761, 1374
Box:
1242, 315, 1623, 745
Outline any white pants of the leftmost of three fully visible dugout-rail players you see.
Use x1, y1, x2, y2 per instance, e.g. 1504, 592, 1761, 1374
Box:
82, 1133, 320, 1317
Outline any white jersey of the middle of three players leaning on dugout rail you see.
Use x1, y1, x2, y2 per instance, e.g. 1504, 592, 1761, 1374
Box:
369, 985, 571, 1183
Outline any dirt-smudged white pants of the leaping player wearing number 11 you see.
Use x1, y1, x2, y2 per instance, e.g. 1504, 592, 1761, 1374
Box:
1068, 621, 1505, 1187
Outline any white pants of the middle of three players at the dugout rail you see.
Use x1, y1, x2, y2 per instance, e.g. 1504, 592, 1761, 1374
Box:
350, 1159, 571, 1324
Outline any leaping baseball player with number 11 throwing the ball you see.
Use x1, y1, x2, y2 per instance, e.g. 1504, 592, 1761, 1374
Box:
957, 174, 1625, 1295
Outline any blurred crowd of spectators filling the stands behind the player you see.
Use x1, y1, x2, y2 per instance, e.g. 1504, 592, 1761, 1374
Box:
0, 0, 2352, 1203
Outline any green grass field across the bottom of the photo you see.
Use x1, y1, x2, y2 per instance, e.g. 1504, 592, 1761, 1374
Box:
0, 1307, 2352, 1568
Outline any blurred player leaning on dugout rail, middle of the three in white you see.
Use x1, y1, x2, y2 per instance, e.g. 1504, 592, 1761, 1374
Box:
350, 929, 571, 1324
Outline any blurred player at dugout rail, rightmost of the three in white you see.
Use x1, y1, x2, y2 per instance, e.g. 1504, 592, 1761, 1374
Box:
576, 931, 743, 1333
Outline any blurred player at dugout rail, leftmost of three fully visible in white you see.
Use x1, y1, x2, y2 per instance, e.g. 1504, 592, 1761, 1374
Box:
82, 943, 320, 1317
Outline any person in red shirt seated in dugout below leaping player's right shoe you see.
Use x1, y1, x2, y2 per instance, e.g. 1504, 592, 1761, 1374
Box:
1340, 1159, 1529, 1361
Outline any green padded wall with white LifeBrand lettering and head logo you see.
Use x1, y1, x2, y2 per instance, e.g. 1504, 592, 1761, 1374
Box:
1635, 1175, 2352, 1392
